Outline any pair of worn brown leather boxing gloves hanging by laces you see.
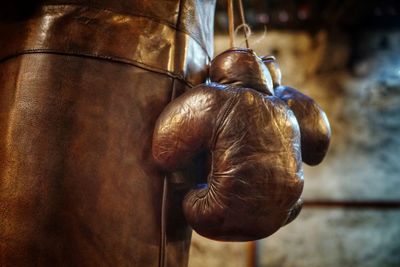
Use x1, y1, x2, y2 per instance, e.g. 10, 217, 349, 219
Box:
152, 48, 331, 241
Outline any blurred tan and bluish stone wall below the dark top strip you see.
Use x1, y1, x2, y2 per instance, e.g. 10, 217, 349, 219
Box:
189, 31, 400, 267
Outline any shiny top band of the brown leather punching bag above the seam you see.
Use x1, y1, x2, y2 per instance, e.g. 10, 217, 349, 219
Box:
0, 0, 214, 85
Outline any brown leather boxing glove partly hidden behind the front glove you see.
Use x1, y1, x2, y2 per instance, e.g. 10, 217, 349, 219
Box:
262, 56, 331, 165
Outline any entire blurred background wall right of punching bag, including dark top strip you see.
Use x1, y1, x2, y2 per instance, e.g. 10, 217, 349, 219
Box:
189, 0, 400, 267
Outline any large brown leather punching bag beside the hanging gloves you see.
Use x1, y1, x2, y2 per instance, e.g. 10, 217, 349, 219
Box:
0, 0, 215, 267
